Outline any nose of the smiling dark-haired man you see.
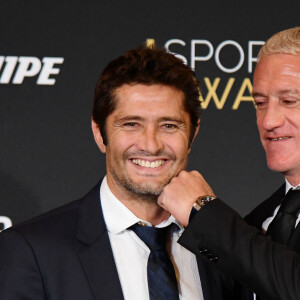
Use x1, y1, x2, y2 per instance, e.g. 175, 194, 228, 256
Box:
138, 126, 163, 155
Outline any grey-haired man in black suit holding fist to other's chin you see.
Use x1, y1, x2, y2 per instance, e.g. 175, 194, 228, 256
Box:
158, 27, 300, 300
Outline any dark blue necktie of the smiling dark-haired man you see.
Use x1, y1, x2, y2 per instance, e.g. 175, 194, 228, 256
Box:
130, 224, 179, 300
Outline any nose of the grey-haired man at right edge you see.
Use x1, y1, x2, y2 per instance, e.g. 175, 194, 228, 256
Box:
262, 103, 285, 130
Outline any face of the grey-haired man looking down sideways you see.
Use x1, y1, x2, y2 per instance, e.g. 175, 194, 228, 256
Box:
253, 54, 300, 177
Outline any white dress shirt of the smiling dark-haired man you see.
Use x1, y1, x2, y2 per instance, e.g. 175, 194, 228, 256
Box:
99, 177, 203, 300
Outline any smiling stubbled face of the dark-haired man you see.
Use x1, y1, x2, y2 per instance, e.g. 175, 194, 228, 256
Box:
93, 84, 198, 198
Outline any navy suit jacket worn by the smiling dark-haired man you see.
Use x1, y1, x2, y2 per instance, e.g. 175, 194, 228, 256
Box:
0, 184, 231, 300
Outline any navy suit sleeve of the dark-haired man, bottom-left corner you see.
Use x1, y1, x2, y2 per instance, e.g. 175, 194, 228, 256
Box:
0, 230, 46, 300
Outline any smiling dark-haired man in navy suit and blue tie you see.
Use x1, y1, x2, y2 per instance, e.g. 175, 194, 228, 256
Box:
0, 47, 233, 300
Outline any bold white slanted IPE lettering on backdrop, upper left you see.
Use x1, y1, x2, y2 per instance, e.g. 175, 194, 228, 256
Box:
0, 56, 64, 85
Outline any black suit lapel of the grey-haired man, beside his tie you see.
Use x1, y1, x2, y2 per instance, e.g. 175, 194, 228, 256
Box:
245, 184, 285, 230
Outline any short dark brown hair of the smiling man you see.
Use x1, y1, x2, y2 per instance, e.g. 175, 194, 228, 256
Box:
93, 46, 201, 145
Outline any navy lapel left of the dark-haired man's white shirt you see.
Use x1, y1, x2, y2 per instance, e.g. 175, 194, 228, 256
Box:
77, 184, 124, 300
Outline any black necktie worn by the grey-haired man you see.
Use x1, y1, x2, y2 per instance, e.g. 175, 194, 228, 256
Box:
267, 189, 300, 245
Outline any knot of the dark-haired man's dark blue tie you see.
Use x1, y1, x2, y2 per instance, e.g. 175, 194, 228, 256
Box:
129, 223, 172, 251
